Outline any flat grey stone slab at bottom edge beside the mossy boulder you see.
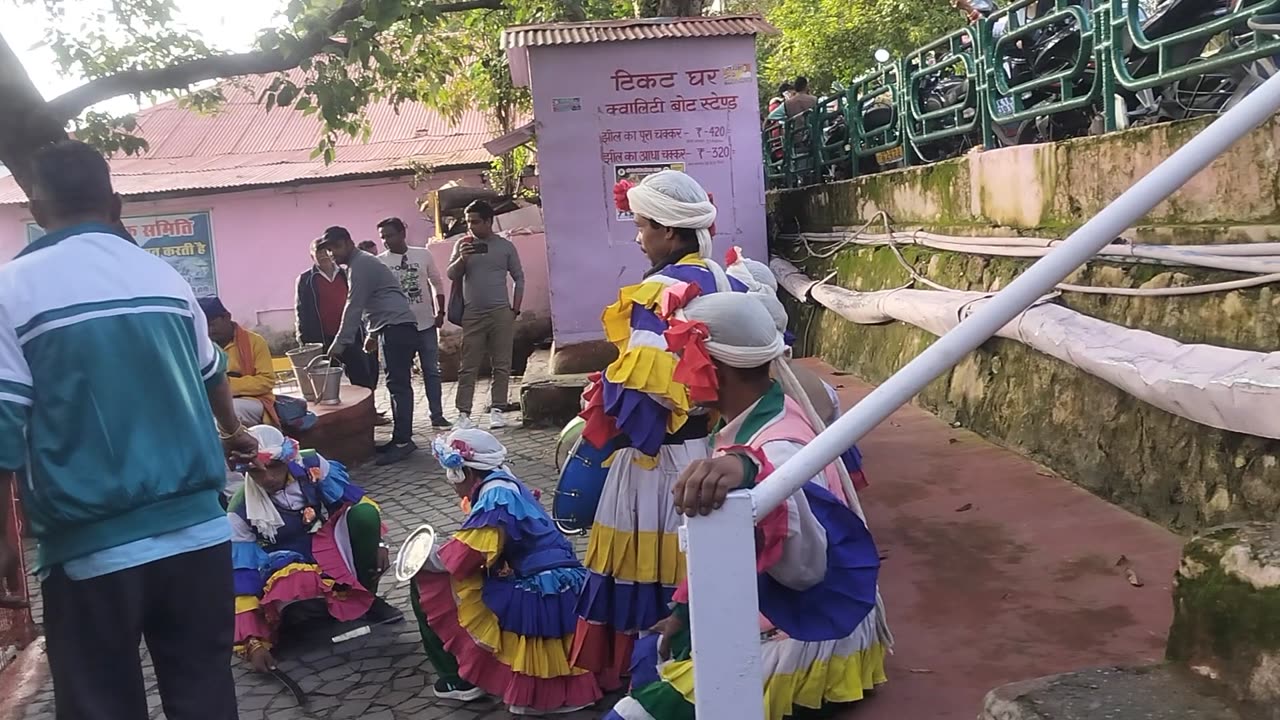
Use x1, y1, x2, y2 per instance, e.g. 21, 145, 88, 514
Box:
978, 665, 1247, 720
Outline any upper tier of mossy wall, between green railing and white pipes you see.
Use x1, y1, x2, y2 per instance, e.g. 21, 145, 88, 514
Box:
771, 117, 1280, 233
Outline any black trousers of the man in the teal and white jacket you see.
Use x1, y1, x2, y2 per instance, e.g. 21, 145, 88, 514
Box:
41, 543, 238, 720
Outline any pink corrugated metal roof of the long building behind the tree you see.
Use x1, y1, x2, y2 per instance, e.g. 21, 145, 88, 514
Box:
0, 73, 509, 205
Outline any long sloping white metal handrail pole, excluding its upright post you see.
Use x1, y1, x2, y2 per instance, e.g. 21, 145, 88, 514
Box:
752, 76, 1280, 515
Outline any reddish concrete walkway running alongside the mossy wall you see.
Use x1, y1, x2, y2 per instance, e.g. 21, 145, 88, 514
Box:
803, 360, 1181, 720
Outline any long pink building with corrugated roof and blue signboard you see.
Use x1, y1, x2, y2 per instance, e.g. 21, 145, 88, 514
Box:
0, 76, 549, 343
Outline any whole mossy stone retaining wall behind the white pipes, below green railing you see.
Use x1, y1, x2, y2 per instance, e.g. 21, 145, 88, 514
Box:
771, 122, 1280, 532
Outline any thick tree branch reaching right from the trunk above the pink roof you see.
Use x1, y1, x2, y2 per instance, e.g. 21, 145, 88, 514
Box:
41, 0, 503, 122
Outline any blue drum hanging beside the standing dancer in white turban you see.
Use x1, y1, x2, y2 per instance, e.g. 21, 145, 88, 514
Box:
552, 418, 622, 536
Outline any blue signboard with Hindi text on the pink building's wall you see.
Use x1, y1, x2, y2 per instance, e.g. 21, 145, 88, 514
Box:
27, 211, 218, 297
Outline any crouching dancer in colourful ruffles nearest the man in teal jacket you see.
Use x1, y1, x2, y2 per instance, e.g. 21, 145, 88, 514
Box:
227, 425, 404, 671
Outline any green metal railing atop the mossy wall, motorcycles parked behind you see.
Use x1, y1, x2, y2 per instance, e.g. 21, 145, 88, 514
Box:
764, 0, 1280, 187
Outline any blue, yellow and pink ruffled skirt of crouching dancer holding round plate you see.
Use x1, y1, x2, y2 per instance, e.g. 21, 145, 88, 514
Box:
413, 568, 602, 714
